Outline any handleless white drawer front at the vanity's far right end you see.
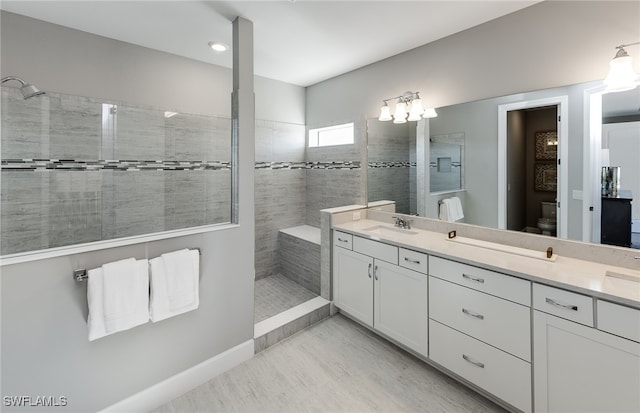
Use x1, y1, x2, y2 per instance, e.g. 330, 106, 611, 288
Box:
596, 300, 640, 342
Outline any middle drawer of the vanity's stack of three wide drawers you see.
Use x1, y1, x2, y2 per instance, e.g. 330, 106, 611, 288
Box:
429, 277, 531, 361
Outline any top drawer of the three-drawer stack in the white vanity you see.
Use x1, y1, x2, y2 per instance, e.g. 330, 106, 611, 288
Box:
429, 256, 531, 306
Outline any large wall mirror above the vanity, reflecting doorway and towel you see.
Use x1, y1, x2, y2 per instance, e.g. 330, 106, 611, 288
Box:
367, 82, 640, 247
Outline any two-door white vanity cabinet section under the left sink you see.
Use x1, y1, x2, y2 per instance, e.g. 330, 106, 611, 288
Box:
333, 231, 427, 355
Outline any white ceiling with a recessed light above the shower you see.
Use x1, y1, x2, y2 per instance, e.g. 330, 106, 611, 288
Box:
0, 0, 538, 86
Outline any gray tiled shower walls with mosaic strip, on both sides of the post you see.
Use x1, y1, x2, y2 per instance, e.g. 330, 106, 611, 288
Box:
0, 87, 366, 278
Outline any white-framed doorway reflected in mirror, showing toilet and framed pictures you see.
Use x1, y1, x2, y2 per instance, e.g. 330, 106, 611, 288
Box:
498, 96, 568, 238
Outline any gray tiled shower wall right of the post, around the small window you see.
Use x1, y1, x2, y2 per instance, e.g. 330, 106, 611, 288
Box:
255, 120, 366, 279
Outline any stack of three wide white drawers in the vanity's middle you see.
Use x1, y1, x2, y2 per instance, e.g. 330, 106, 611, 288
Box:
429, 256, 532, 412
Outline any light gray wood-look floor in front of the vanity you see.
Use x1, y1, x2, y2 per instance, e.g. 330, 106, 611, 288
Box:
153, 315, 504, 413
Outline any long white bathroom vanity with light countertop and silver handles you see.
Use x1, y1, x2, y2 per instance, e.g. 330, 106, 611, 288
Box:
331, 209, 640, 412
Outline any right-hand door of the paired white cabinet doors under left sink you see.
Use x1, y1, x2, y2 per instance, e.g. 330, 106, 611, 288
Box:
374, 260, 427, 355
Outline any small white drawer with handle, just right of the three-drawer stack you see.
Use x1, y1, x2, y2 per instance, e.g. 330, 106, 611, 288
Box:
533, 284, 593, 327
